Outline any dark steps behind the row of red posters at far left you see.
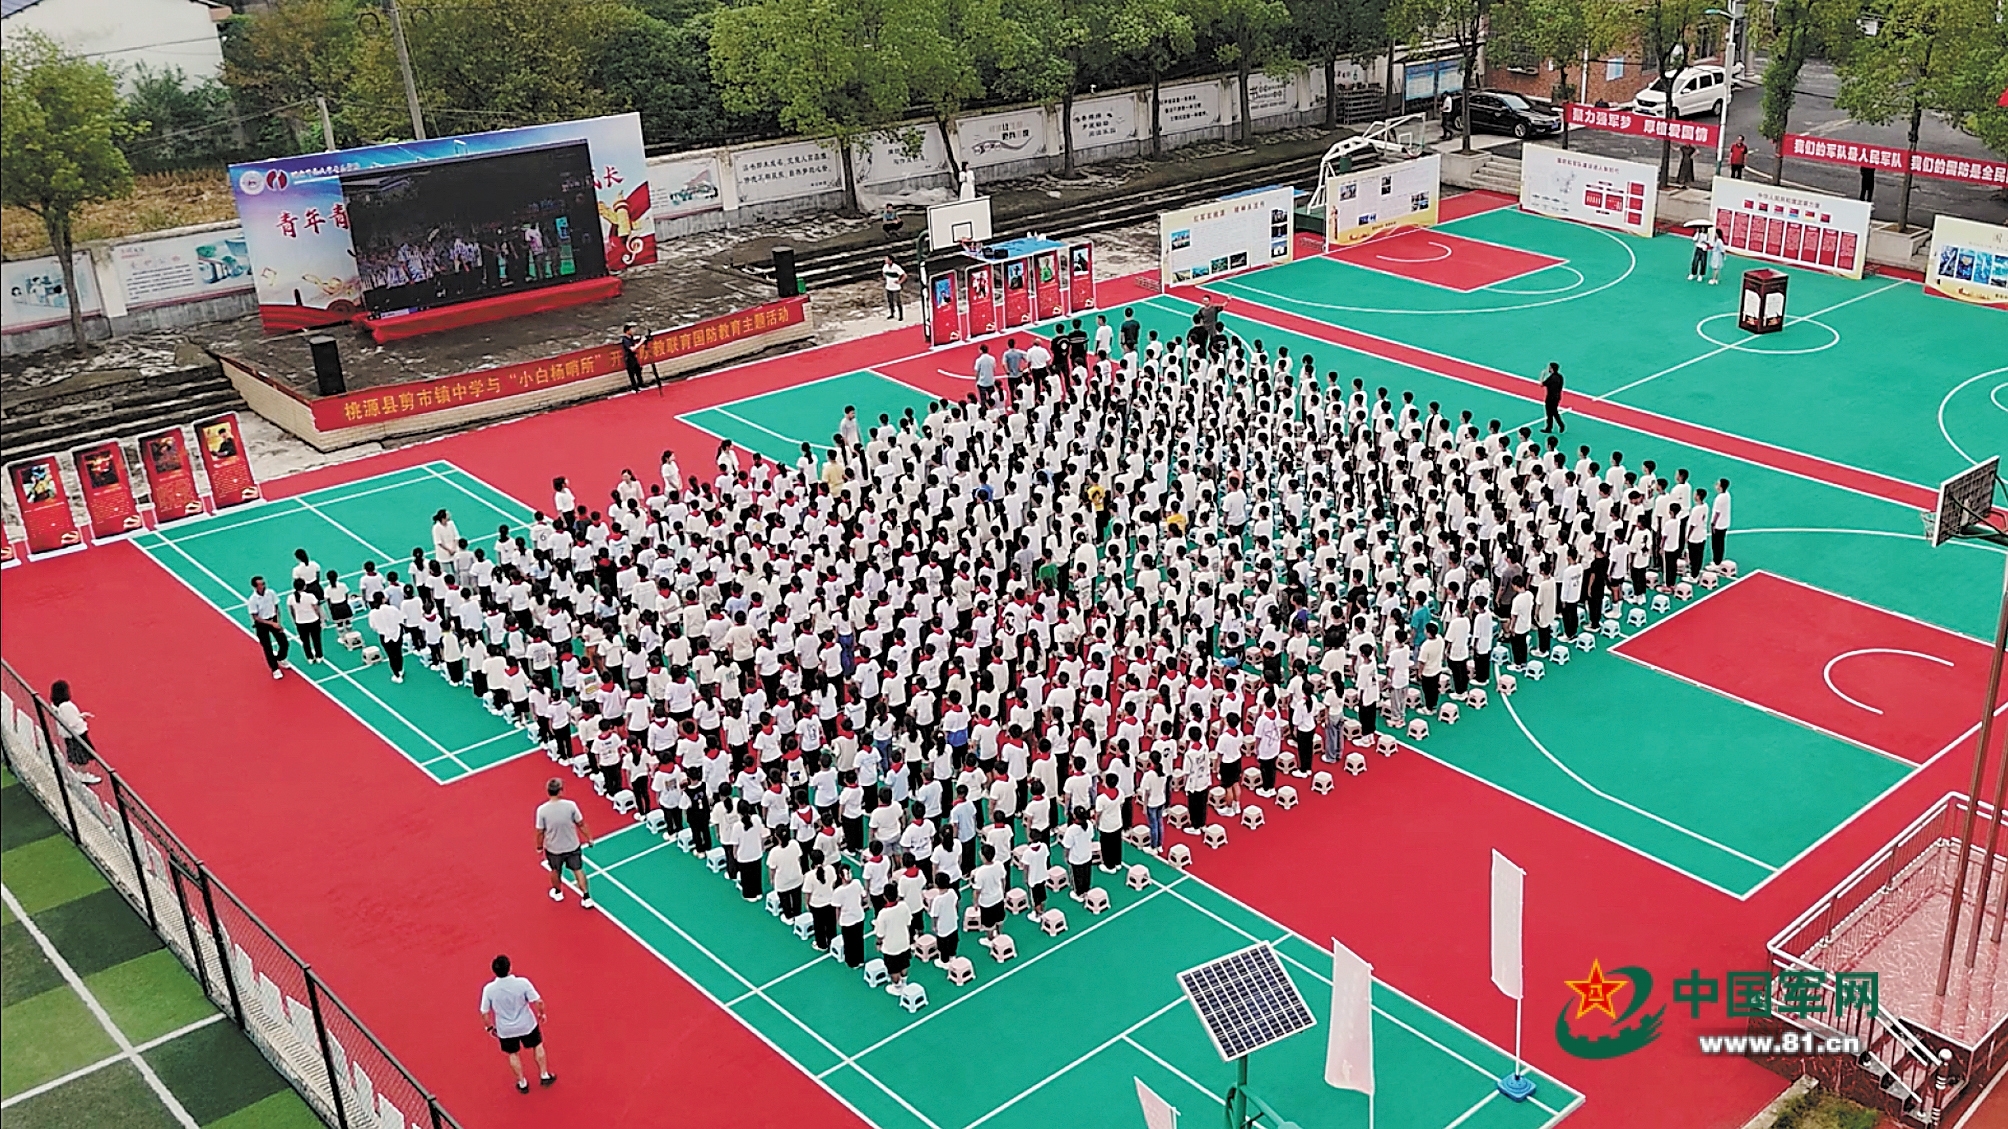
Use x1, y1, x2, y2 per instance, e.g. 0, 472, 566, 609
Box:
0, 350, 245, 462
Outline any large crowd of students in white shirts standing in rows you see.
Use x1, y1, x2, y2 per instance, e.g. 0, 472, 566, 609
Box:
263, 319, 1729, 990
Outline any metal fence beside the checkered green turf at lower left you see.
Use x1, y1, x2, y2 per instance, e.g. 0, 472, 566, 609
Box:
0, 661, 460, 1129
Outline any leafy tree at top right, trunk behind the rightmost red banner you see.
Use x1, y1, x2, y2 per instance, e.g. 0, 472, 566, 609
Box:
1833, 0, 1994, 231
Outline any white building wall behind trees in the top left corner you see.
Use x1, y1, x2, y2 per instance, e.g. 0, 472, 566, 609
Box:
0, 0, 223, 80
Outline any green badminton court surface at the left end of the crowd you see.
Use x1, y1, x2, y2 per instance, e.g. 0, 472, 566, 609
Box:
133, 462, 534, 783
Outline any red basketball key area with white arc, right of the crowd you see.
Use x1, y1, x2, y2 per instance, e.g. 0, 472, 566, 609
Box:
1610, 573, 1990, 763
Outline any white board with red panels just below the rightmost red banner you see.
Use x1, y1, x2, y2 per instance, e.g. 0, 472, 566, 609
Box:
1715, 179, 1869, 279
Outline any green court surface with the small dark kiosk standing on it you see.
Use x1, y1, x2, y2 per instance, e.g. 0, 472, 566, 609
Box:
1207, 209, 2008, 486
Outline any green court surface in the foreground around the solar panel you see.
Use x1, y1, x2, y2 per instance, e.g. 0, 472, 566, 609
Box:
586, 826, 1582, 1129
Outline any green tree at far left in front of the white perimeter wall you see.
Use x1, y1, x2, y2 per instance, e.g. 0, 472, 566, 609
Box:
0, 32, 133, 354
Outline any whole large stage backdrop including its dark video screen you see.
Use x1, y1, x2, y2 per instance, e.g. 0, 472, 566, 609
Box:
231, 115, 655, 331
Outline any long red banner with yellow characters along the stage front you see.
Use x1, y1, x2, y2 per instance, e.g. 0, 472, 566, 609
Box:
313, 295, 809, 432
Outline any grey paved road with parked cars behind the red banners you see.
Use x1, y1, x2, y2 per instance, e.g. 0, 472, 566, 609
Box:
1501, 58, 2008, 227
